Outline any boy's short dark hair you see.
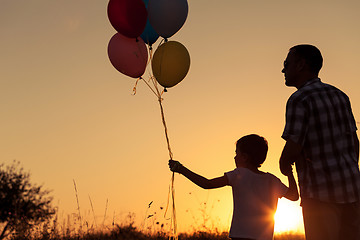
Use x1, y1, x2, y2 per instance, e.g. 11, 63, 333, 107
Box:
236, 134, 268, 167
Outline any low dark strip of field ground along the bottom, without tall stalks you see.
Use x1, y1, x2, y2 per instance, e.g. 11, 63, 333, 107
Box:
3, 215, 305, 240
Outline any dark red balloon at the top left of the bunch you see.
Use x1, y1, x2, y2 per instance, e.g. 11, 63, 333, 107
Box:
107, 0, 148, 38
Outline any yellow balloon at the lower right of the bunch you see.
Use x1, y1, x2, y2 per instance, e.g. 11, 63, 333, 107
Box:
151, 41, 190, 88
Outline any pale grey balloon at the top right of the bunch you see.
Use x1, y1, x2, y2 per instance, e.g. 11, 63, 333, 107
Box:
148, 0, 189, 38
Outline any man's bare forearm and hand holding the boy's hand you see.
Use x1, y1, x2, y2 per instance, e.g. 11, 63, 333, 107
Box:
279, 140, 302, 176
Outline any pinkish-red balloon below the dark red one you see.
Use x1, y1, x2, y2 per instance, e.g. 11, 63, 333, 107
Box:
108, 33, 148, 78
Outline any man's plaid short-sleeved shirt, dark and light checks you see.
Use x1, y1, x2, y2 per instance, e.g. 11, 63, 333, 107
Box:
282, 78, 360, 203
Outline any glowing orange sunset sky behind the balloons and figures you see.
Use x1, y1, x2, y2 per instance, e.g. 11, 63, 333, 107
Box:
0, 0, 360, 231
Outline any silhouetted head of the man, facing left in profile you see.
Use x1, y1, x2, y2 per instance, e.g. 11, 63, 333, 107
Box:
281, 44, 323, 88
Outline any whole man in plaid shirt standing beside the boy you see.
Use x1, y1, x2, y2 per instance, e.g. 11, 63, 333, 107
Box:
280, 45, 360, 240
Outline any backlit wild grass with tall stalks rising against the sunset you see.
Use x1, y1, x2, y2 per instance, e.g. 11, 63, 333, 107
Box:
2, 180, 305, 240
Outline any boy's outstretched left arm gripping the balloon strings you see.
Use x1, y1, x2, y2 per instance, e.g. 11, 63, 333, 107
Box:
169, 160, 229, 189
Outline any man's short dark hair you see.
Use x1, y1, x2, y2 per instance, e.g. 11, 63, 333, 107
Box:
290, 44, 323, 74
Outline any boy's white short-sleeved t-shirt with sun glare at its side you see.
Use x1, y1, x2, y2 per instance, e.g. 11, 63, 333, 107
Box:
225, 168, 288, 240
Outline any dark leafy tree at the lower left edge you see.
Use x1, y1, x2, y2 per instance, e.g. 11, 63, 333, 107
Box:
0, 161, 55, 239
